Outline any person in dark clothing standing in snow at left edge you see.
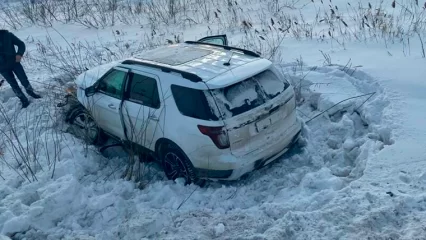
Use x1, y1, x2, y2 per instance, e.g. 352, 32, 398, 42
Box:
0, 29, 41, 108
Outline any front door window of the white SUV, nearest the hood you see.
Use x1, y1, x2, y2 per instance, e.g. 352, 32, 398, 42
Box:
98, 69, 126, 99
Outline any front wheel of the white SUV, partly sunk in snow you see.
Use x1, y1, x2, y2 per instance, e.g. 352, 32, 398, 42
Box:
68, 105, 107, 145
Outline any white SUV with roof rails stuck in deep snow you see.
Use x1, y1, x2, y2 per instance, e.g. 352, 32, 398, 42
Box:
62, 35, 301, 183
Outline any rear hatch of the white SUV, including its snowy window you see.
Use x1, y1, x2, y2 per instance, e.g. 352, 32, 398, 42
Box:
210, 69, 296, 157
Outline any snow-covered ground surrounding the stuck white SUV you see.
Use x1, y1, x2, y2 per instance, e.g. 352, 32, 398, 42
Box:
0, 0, 426, 240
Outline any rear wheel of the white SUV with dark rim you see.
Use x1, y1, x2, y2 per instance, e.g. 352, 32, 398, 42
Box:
158, 142, 204, 186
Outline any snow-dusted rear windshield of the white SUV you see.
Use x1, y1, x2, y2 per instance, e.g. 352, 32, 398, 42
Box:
212, 70, 290, 118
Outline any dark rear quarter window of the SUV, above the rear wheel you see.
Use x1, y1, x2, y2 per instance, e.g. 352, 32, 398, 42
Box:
171, 85, 219, 121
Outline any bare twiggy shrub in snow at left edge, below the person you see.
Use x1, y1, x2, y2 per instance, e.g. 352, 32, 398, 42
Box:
0, 88, 66, 182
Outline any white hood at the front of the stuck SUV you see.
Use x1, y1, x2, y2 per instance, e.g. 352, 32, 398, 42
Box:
74, 60, 123, 89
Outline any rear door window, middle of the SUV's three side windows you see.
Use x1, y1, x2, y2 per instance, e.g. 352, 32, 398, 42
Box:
128, 72, 160, 109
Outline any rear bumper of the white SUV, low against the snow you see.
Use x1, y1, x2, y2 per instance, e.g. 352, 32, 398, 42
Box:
196, 120, 302, 180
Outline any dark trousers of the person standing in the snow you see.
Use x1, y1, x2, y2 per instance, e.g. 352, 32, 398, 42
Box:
0, 63, 33, 102
